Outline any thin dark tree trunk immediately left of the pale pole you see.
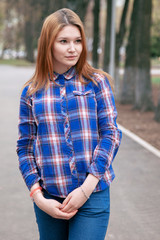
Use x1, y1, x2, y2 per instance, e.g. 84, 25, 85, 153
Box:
103, 0, 112, 72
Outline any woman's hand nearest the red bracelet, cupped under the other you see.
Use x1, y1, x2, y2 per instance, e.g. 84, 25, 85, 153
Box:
34, 192, 77, 220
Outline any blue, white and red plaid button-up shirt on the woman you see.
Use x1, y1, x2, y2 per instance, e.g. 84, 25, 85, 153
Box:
17, 67, 122, 197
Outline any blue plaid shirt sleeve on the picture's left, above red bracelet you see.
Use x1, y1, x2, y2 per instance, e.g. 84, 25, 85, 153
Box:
17, 87, 40, 189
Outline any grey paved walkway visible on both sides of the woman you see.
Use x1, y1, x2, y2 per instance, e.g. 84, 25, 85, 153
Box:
0, 66, 160, 240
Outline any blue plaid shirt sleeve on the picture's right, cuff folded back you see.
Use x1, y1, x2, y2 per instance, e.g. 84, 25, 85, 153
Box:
89, 77, 122, 179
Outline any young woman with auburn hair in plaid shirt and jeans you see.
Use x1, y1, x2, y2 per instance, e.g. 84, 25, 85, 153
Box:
17, 9, 121, 240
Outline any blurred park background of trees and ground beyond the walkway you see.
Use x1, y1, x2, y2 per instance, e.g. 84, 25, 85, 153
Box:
0, 0, 160, 149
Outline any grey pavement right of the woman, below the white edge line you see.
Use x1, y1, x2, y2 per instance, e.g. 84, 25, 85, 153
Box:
106, 135, 160, 240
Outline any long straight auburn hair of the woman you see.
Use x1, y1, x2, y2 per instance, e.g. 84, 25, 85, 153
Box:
25, 8, 111, 95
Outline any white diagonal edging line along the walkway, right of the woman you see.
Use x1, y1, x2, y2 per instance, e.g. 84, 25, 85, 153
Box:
118, 124, 160, 158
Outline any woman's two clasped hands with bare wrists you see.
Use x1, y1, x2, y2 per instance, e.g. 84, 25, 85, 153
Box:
31, 174, 99, 220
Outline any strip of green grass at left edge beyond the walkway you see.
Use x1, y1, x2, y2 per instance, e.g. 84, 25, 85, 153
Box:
0, 59, 34, 67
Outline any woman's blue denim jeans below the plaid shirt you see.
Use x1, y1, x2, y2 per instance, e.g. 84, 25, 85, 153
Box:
34, 187, 110, 240
